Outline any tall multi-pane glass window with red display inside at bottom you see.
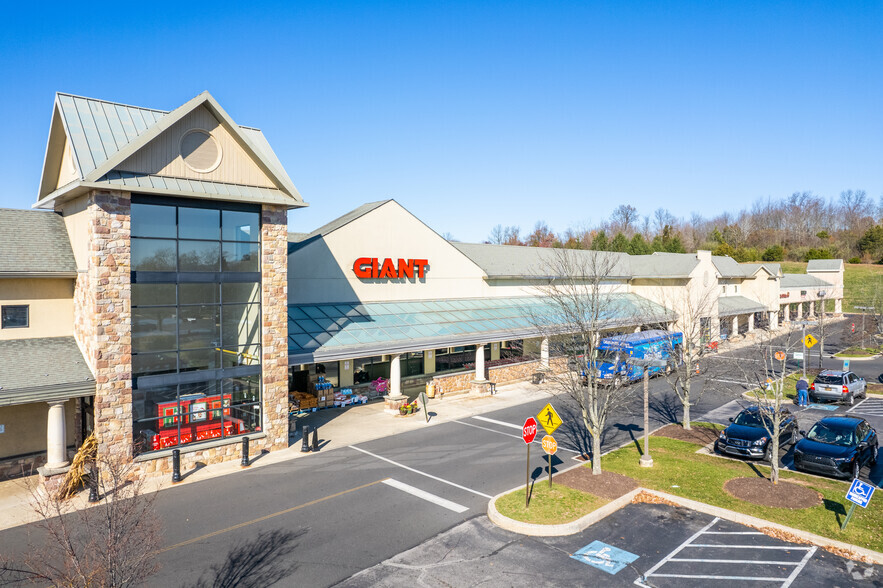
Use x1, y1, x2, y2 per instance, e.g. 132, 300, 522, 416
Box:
131, 197, 262, 453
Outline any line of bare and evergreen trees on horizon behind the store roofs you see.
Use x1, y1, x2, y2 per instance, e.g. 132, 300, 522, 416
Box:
487, 190, 883, 263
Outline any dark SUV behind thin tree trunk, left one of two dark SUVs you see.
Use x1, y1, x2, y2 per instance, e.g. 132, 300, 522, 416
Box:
714, 405, 798, 461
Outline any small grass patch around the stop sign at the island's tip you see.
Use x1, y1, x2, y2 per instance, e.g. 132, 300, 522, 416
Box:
497, 477, 609, 525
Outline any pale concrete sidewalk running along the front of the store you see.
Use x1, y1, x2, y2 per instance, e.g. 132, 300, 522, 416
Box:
0, 382, 553, 530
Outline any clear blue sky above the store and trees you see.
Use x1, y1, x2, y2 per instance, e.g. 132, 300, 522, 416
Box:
0, 1, 883, 241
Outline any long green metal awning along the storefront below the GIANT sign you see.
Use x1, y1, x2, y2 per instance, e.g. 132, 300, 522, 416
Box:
288, 293, 675, 363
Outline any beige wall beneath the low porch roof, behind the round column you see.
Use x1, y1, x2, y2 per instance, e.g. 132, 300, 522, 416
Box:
0, 399, 77, 459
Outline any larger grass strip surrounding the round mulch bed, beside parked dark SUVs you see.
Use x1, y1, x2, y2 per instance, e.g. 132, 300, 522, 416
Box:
604, 430, 883, 551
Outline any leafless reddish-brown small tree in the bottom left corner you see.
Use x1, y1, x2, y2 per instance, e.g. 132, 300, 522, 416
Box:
0, 450, 160, 588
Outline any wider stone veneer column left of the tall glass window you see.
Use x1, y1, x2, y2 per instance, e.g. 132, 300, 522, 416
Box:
74, 191, 132, 460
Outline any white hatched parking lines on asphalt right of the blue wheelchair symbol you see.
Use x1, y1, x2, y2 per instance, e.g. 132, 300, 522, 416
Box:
634, 518, 816, 588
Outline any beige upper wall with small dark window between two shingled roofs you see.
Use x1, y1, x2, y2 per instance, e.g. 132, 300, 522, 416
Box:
0, 278, 74, 340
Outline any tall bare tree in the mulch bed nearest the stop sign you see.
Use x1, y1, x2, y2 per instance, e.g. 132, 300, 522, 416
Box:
529, 249, 670, 474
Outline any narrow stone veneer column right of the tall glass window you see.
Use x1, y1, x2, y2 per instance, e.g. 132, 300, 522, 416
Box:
261, 205, 288, 450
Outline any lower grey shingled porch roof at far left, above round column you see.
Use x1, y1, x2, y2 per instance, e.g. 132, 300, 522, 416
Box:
0, 337, 95, 406
